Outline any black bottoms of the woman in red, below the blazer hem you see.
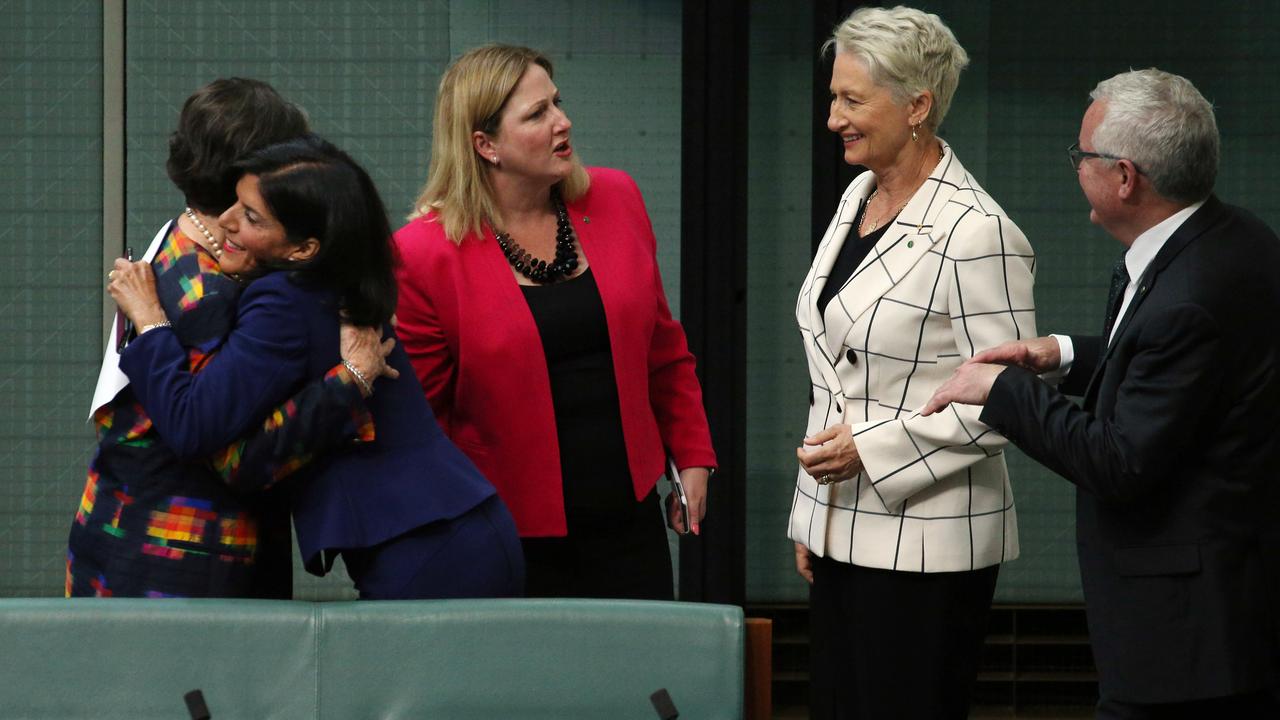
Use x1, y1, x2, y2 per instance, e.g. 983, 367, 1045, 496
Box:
520, 489, 675, 600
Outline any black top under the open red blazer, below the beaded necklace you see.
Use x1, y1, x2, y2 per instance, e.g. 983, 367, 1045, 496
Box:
520, 268, 635, 512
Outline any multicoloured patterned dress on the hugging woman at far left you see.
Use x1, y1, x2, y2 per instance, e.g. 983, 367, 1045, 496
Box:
65, 222, 372, 597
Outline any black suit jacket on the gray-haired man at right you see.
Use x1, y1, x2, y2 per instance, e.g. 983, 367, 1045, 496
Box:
982, 197, 1280, 703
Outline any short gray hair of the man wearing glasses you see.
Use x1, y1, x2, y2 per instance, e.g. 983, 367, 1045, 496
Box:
1089, 68, 1219, 204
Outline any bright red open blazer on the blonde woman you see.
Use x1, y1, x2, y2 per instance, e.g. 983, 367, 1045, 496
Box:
396, 168, 716, 537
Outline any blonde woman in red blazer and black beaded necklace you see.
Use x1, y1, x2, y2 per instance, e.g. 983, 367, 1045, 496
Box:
396, 45, 716, 598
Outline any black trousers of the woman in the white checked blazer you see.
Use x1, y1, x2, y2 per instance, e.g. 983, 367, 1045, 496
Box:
809, 557, 1000, 720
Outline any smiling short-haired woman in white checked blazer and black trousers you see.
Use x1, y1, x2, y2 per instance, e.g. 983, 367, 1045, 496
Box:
790, 8, 1036, 720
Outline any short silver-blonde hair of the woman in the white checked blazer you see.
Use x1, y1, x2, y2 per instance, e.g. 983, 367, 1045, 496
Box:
822, 5, 969, 131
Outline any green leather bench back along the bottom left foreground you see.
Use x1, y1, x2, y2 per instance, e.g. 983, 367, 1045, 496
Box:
0, 598, 744, 720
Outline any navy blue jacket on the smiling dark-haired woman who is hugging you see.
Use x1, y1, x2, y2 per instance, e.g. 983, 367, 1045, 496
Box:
120, 272, 495, 575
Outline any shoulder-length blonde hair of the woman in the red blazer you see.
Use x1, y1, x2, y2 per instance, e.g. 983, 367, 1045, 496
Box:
410, 45, 591, 242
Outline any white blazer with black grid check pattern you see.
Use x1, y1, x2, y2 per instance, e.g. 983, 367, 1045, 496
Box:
788, 143, 1036, 573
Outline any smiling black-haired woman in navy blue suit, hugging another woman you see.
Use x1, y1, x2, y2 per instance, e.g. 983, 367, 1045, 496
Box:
107, 136, 524, 598
